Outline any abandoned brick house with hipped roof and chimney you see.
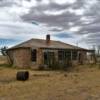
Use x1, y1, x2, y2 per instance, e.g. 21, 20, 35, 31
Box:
7, 35, 94, 69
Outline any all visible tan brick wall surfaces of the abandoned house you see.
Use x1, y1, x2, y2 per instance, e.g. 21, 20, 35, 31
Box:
9, 48, 86, 69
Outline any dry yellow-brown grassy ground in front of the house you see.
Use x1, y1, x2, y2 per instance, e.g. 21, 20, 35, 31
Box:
0, 65, 100, 100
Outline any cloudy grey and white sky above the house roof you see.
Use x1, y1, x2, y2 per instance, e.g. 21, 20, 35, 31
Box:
0, 0, 100, 47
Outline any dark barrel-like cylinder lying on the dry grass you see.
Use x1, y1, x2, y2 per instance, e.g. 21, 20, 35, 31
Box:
16, 71, 29, 81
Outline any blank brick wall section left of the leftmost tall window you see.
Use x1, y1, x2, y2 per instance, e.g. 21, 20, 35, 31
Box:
9, 48, 31, 68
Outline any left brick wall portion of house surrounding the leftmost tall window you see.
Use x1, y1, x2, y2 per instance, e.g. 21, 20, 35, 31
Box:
8, 48, 43, 69
